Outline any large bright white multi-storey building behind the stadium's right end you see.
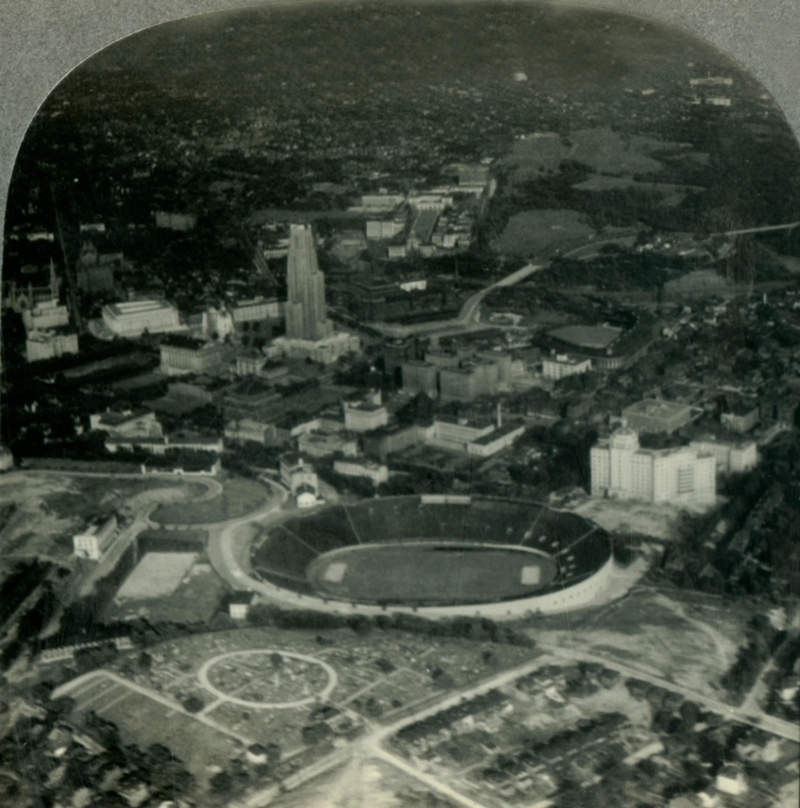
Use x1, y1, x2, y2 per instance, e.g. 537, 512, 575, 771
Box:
591, 427, 717, 504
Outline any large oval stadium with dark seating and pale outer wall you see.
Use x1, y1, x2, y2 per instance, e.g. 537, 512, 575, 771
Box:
251, 495, 613, 618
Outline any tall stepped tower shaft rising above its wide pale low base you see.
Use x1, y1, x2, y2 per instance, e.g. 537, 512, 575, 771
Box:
286, 224, 333, 342
